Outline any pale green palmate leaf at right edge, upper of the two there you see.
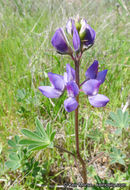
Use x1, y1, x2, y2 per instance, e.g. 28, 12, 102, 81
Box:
106, 109, 130, 129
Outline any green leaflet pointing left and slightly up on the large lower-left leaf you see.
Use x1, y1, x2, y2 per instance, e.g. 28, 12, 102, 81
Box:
21, 129, 43, 141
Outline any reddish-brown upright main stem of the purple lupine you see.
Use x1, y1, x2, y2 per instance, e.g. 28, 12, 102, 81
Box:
75, 60, 87, 183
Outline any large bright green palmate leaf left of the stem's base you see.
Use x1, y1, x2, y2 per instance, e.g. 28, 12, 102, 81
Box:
19, 118, 55, 151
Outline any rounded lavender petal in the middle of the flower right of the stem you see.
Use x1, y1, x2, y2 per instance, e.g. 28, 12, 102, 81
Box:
82, 79, 100, 96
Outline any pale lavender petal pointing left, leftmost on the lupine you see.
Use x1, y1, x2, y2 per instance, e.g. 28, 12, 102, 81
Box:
39, 86, 62, 98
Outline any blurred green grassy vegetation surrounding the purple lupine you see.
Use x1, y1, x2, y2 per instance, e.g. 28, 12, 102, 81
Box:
0, 0, 130, 190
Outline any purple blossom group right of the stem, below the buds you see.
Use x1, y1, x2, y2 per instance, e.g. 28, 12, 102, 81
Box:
82, 60, 109, 107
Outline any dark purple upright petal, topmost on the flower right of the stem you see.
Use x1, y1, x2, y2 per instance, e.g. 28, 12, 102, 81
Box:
85, 60, 98, 79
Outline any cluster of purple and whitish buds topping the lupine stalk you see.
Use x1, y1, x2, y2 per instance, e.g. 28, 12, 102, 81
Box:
51, 18, 96, 55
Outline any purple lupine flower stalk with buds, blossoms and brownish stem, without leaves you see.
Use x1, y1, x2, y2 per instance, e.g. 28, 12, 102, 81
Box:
39, 18, 109, 183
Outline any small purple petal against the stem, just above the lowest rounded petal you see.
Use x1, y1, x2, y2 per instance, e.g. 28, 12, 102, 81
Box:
66, 81, 79, 97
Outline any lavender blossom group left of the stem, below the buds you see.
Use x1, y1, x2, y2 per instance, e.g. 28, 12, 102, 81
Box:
39, 64, 79, 112
